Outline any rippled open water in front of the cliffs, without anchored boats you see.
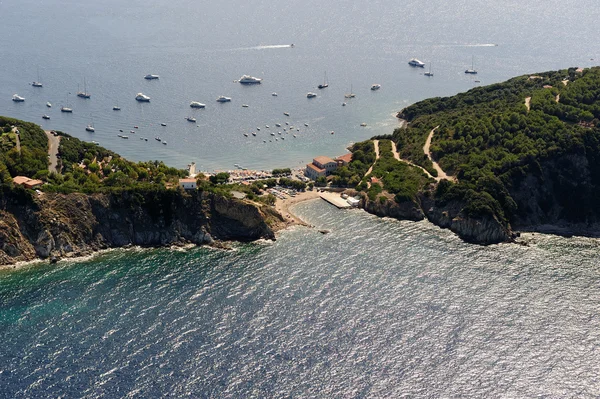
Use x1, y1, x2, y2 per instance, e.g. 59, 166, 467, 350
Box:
0, 200, 600, 398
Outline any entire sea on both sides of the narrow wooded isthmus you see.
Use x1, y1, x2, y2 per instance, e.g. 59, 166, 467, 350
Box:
0, 0, 600, 398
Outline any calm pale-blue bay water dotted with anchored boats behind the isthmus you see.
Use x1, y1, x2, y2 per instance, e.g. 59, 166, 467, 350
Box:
0, 0, 600, 170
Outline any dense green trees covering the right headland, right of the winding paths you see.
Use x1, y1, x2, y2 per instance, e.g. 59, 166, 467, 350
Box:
394, 68, 600, 223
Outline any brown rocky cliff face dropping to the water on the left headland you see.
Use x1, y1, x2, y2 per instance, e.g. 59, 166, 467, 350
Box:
0, 191, 280, 264
